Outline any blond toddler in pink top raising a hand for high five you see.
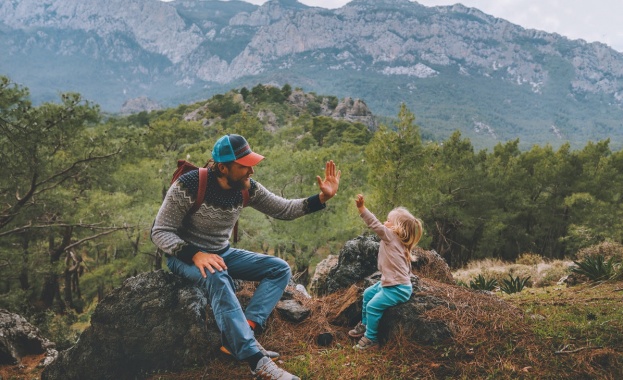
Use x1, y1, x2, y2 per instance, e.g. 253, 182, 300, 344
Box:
348, 194, 422, 350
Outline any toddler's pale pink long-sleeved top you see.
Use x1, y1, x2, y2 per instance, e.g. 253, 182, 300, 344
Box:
360, 209, 411, 286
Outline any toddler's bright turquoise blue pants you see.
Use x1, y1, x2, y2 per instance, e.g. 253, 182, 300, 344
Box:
361, 281, 413, 342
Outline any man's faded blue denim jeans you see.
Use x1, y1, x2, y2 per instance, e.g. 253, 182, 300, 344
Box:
167, 248, 292, 360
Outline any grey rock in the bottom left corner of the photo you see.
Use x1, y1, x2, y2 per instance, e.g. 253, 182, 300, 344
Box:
0, 309, 58, 366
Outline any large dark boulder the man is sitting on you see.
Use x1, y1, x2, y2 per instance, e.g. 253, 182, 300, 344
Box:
41, 270, 220, 380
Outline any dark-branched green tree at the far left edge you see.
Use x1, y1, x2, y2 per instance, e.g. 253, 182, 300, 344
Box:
0, 77, 123, 308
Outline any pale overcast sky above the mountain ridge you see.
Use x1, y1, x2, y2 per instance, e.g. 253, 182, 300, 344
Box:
173, 0, 623, 52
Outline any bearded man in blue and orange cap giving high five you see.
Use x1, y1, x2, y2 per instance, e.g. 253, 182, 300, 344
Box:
151, 134, 341, 380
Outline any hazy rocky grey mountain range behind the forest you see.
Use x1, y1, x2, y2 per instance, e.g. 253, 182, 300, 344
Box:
0, 0, 623, 148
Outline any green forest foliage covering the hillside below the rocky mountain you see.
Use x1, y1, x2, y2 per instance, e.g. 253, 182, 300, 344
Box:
0, 78, 623, 342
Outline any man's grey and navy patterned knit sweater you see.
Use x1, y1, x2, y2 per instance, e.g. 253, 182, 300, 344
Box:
151, 170, 326, 263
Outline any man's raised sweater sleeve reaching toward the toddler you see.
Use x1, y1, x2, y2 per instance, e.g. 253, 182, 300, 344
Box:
249, 182, 327, 220
